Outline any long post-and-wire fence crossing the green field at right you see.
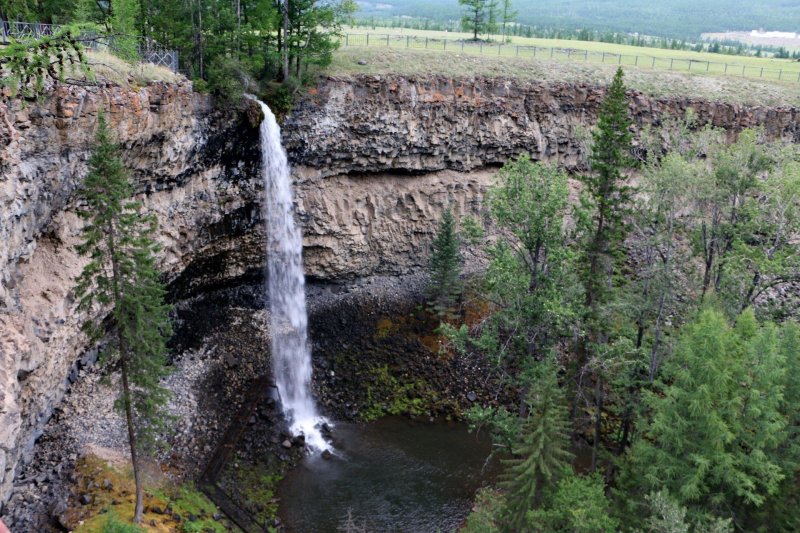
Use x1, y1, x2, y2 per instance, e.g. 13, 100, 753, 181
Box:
340, 33, 800, 83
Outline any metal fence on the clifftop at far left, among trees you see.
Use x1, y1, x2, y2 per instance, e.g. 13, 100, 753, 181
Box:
0, 20, 179, 72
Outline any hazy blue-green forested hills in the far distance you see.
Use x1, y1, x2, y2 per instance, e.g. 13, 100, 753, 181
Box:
358, 0, 800, 38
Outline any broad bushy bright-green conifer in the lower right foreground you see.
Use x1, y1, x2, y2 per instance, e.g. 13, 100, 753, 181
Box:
632, 310, 787, 518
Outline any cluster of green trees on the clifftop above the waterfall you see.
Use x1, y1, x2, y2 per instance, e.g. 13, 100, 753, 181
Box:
5, 0, 356, 99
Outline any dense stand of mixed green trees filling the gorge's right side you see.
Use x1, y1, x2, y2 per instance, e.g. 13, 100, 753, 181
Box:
430, 70, 800, 533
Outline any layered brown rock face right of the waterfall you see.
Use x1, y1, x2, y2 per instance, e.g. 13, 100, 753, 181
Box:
284, 76, 800, 278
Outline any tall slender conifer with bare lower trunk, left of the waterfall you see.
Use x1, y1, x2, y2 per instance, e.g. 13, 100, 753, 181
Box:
76, 114, 171, 522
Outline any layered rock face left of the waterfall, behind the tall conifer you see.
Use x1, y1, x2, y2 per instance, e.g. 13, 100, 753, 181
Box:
0, 84, 259, 502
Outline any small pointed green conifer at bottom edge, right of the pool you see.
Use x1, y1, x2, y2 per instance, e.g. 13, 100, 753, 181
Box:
501, 361, 572, 531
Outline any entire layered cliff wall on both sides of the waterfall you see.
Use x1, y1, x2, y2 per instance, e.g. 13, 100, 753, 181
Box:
0, 77, 800, 508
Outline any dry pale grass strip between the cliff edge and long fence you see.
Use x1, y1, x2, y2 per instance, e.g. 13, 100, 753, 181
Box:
326, 47, 800, 107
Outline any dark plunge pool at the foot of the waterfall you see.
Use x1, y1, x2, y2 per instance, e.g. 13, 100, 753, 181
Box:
278, 418, 493, 533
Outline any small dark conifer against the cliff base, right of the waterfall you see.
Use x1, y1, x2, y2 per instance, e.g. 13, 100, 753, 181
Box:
428, 208, 461, 318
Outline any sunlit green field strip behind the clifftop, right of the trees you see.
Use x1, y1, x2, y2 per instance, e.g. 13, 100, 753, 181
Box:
341, 28, 800, 84
